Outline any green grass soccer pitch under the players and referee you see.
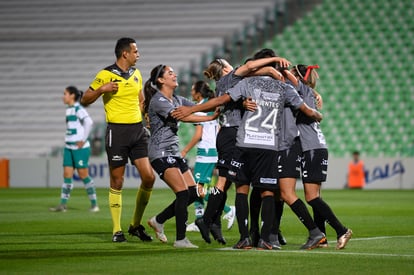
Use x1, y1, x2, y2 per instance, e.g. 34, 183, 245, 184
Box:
0, 189, 414, 274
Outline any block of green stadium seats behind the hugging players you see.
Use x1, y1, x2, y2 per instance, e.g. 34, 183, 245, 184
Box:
265, 0, 414, 157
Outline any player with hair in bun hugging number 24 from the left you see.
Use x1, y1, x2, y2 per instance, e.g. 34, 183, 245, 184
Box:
174, 57, 290, 243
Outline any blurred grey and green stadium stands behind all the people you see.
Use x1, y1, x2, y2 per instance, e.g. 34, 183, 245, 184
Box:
0, 0, 414, 188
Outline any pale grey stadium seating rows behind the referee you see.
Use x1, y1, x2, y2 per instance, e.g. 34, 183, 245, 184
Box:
0, 0, 274, 157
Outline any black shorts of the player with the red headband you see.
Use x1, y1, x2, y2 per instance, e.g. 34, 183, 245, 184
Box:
302, 148, 328, 183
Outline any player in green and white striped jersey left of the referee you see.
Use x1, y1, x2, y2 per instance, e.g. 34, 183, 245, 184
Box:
49, 86, 99, 212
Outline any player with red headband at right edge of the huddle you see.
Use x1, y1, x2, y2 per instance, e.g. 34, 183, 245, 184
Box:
291, 65, 352, 249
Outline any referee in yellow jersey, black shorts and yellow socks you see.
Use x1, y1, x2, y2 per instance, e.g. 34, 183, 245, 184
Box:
81, 38, 155, 242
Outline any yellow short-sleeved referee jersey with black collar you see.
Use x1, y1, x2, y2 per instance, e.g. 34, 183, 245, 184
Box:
90, 64, 142, 124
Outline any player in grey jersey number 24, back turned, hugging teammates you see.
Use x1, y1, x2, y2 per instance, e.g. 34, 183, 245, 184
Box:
173, 68, 322, 250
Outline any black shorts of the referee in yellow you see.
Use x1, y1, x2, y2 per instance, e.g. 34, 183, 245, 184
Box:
105, 123, 148, 168
